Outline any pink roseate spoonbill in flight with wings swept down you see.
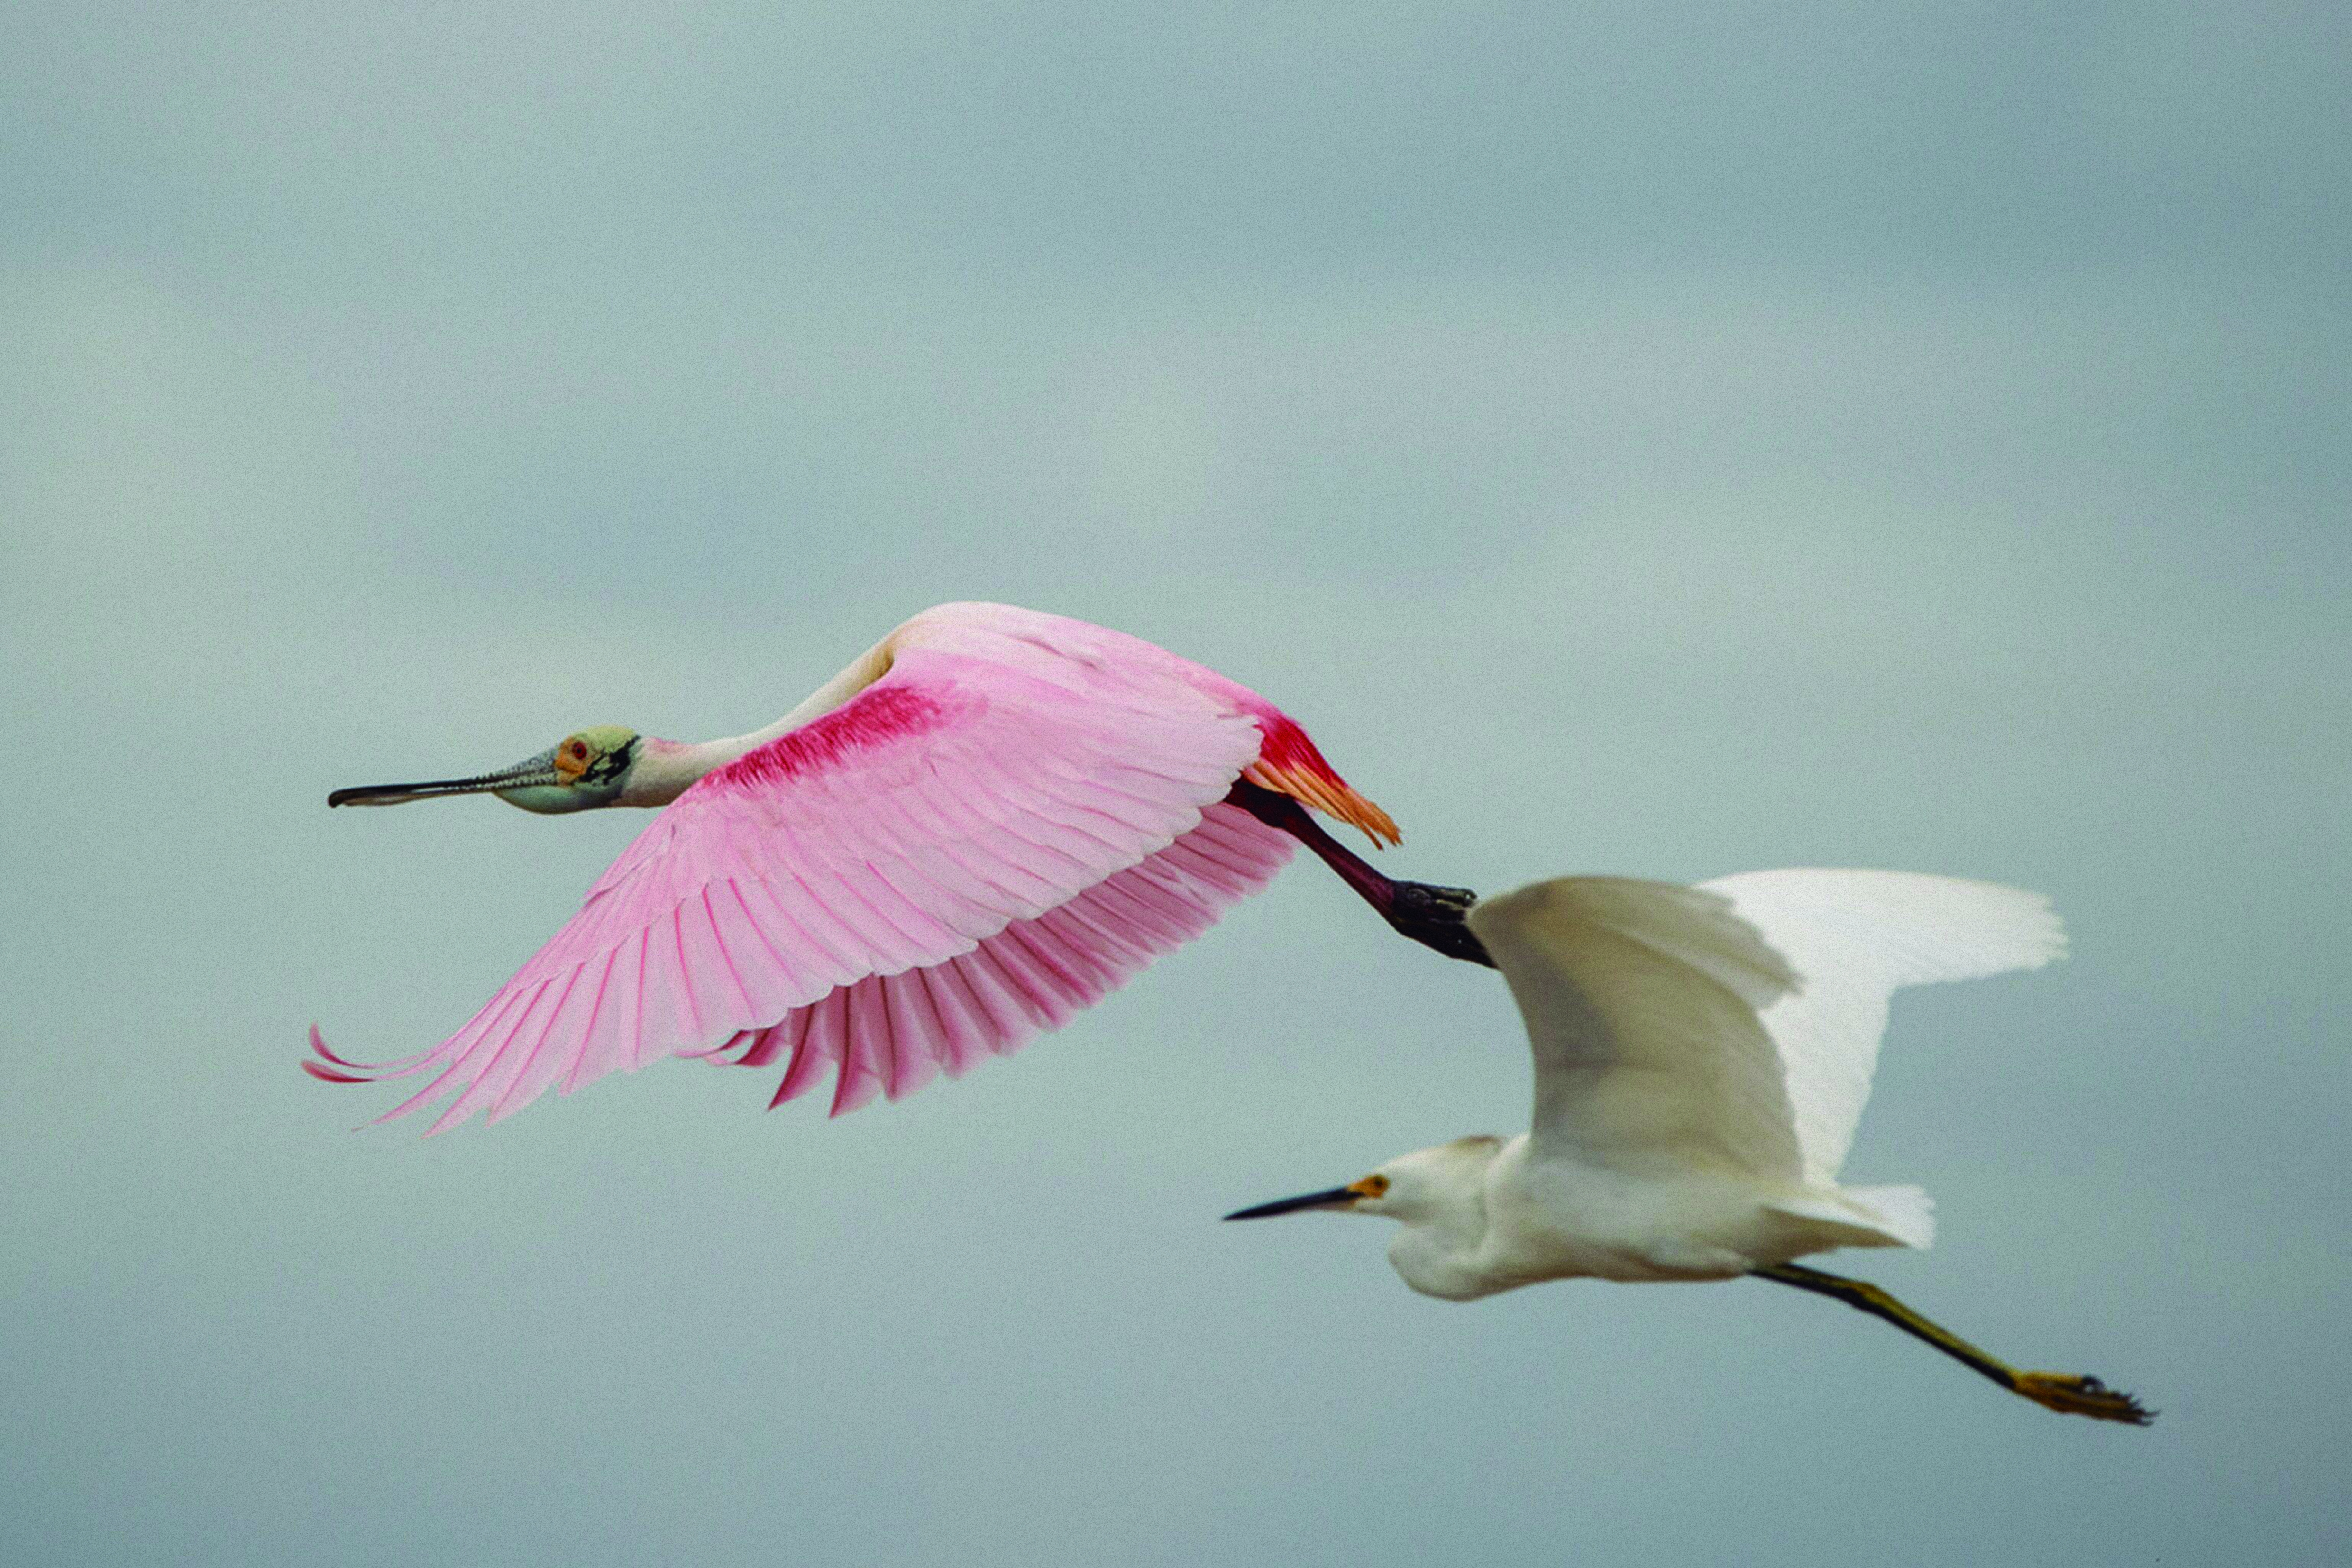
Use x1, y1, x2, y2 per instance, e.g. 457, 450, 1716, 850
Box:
317, 604, 1489, 1133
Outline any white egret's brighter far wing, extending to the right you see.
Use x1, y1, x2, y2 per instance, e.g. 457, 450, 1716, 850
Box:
1698, 870, 2065, 1180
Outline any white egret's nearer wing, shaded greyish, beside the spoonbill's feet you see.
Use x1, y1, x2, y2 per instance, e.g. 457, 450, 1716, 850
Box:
1470, 877, 1802, 1183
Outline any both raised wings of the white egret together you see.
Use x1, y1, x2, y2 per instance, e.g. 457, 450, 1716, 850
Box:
1470, 870, 2065, 1185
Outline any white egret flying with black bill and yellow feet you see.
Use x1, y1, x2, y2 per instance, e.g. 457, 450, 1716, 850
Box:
1226, 870, 2154, 1425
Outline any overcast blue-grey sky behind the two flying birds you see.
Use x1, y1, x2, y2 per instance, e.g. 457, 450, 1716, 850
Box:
0, 0, 2352, 1568
